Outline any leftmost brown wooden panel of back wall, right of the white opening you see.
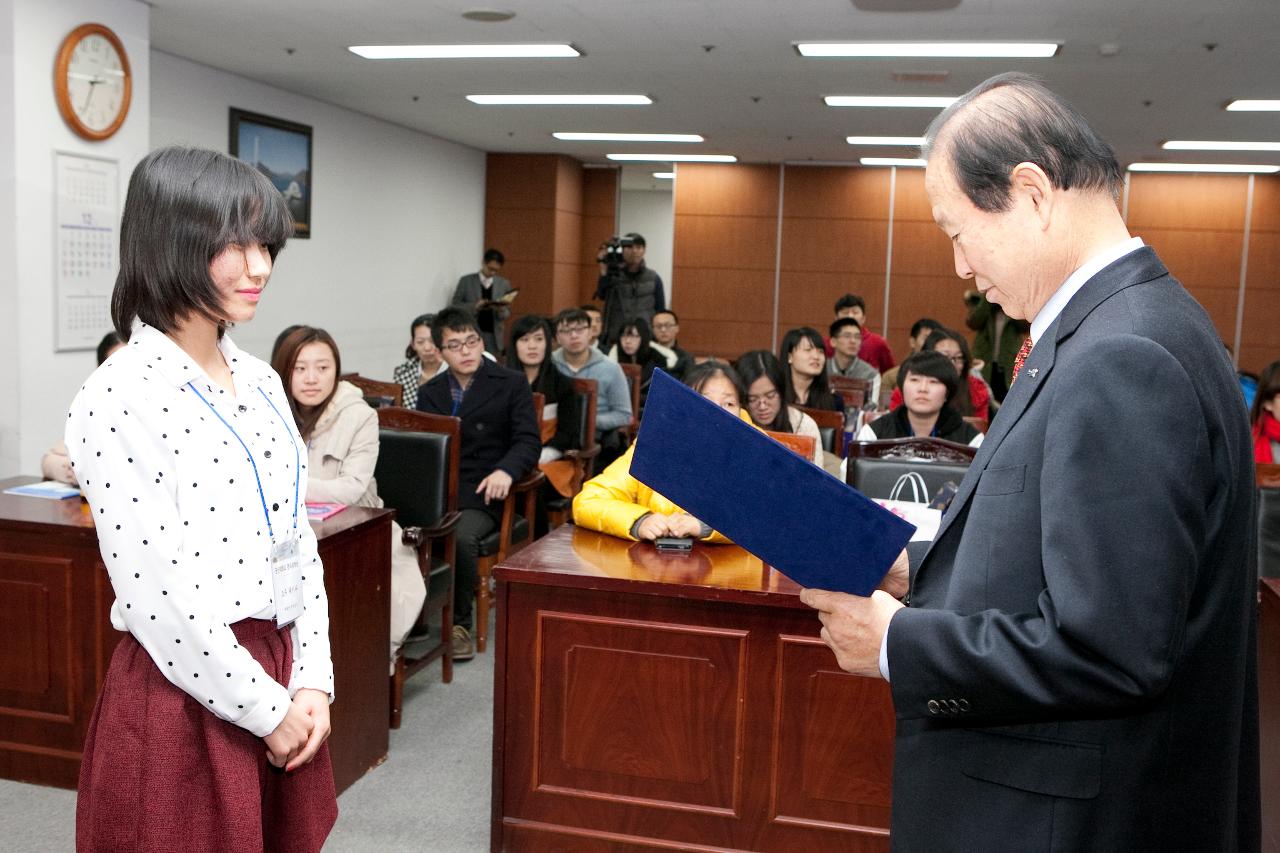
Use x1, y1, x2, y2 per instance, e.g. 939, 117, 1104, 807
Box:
672, 164, 780, 357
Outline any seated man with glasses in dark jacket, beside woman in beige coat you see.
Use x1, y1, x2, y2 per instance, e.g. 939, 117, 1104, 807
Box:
417, 306, 540, 661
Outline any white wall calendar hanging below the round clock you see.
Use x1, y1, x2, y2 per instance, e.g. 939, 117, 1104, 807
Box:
54, 152, 120, 351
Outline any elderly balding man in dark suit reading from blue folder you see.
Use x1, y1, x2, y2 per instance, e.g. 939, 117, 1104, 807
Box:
804, 74, 1260, 853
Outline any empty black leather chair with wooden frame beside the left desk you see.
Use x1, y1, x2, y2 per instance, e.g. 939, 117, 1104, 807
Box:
374, 407, 462, 729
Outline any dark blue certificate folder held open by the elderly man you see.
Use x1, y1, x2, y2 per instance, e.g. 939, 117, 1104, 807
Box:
631, 370, 915, 596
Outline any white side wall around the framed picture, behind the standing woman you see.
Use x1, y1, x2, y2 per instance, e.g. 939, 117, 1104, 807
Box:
151, 51, 485, 380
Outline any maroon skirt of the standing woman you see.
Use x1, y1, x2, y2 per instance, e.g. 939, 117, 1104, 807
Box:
76, 619, 338, 853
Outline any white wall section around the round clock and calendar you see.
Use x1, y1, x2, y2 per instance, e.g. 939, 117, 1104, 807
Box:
0, 0, 151, 475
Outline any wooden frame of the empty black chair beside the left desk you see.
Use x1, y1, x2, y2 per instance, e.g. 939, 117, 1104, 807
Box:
378, 406, 462, 729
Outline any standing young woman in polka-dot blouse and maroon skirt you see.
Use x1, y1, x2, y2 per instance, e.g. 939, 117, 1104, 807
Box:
67, 147, 338, 850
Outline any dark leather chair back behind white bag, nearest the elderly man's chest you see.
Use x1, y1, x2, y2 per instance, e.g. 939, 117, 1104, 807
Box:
845, 438, 974, 498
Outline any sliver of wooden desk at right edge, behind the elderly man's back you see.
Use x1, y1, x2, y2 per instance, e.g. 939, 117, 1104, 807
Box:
1258, 579, 1280, 853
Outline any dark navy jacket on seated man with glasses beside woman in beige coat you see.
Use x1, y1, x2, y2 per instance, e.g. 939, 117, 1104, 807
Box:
417, 359, 543, 519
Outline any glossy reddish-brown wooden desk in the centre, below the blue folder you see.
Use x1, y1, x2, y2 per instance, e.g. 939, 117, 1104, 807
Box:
492, 525, 893, 852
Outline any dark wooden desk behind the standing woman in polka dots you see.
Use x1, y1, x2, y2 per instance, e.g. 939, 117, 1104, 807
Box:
0, 476, 394, 792
